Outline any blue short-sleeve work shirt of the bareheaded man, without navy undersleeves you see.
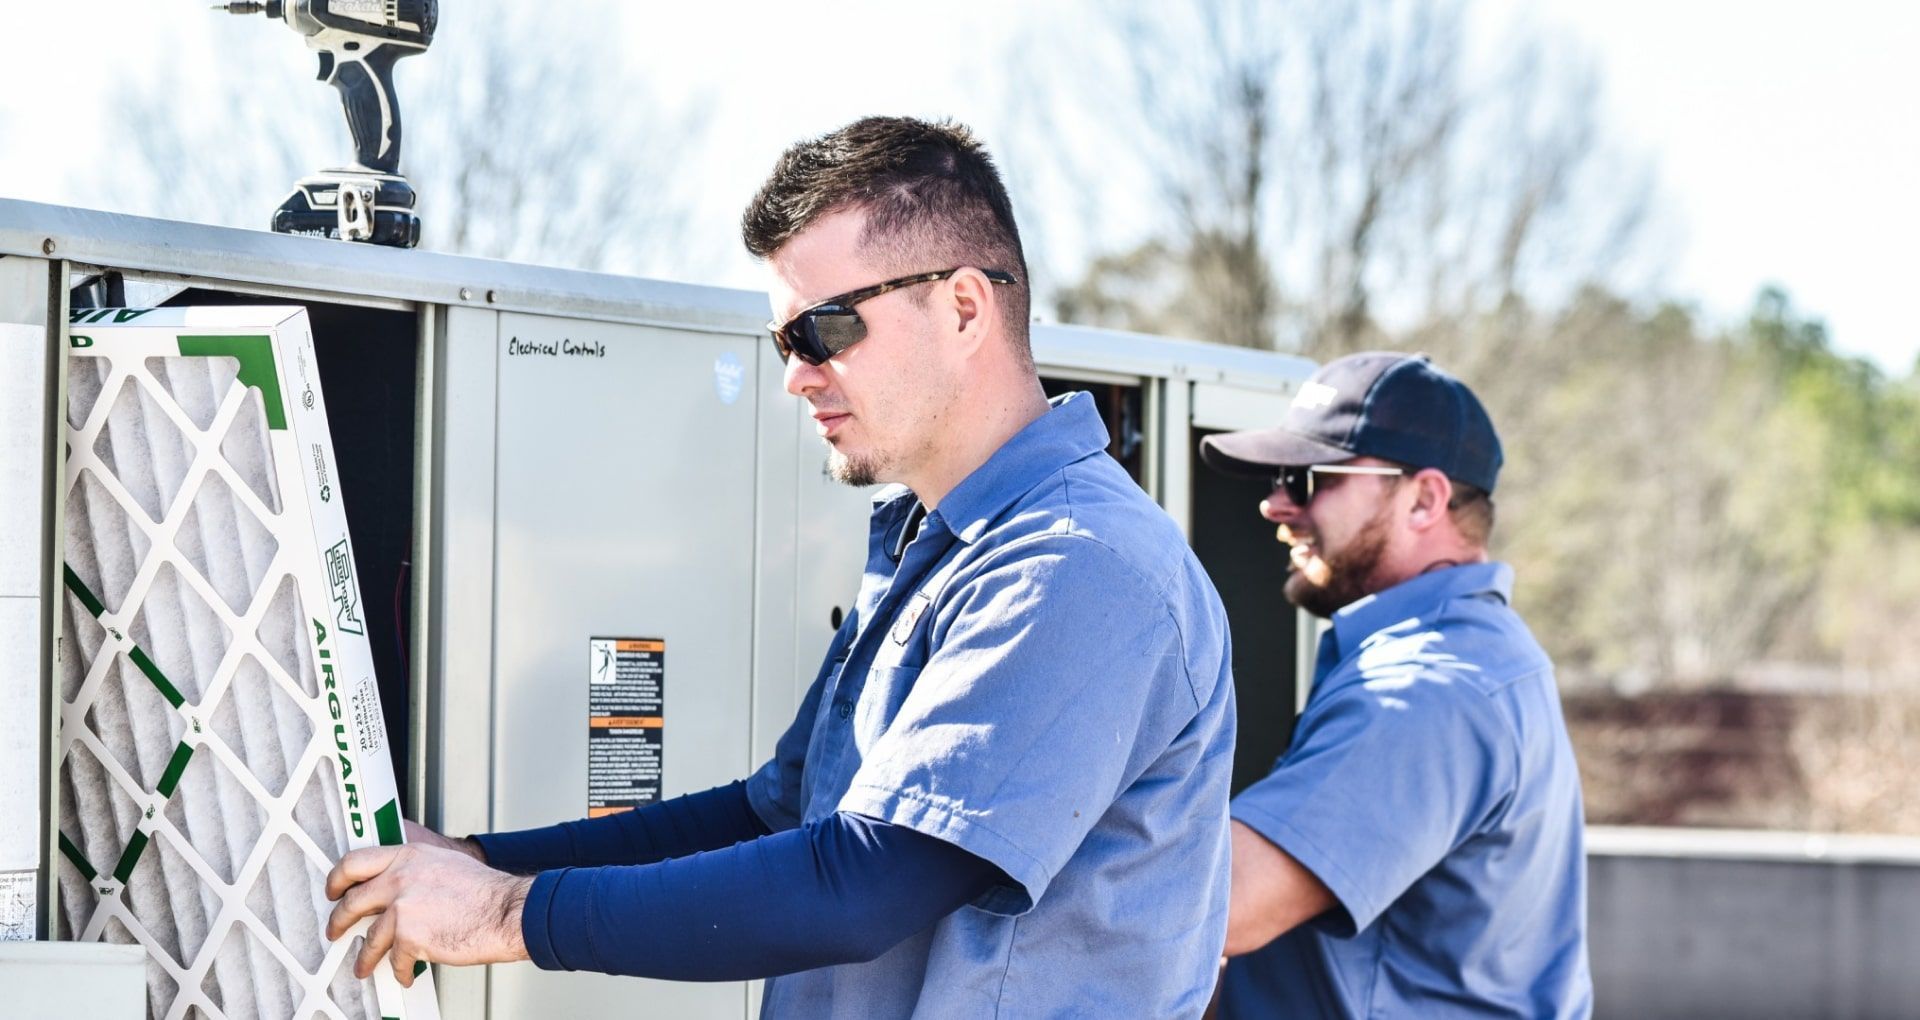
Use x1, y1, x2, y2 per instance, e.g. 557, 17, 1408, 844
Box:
747, 394, 1235, 1020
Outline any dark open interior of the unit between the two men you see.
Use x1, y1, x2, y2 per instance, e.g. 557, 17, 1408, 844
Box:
1192, 428, 1298, 793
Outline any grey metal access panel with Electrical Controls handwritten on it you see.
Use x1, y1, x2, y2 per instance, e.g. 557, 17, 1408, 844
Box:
483, 313, 758, 1016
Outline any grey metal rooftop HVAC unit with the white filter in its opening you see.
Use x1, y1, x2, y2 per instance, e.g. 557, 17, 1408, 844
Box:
0, 198, 1313, 1020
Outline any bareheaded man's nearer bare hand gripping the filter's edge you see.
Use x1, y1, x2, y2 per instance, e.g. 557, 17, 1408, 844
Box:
326, 843, 534, 987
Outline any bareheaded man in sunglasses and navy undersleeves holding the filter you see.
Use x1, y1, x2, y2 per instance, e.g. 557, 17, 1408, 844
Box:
328, 117, 1235, 1018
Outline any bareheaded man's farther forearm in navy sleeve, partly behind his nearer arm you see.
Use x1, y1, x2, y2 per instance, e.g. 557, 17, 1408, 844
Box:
472, 782, 768, 874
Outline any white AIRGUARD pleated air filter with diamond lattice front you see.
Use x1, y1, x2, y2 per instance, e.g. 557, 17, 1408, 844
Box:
58, 307, 438, 1020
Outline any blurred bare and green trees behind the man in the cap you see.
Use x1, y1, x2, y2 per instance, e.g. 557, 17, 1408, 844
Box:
1016, 0, 1920, 703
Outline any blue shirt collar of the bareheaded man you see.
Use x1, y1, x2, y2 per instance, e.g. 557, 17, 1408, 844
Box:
927, 392, 1108, 544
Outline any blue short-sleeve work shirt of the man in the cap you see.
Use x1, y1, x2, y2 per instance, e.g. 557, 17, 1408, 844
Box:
1221, 563, 1594, 1018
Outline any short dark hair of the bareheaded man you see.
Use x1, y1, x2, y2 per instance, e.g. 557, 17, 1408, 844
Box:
739, 117, 1031, 351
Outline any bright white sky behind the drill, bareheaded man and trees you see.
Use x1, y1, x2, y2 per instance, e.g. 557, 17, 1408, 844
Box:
0, 0, 1920, 375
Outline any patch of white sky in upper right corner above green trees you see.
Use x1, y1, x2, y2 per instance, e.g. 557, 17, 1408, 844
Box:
1486, 0, 1920, 375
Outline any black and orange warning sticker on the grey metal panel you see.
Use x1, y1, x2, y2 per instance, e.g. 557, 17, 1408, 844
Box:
588, 638, 666, 818
